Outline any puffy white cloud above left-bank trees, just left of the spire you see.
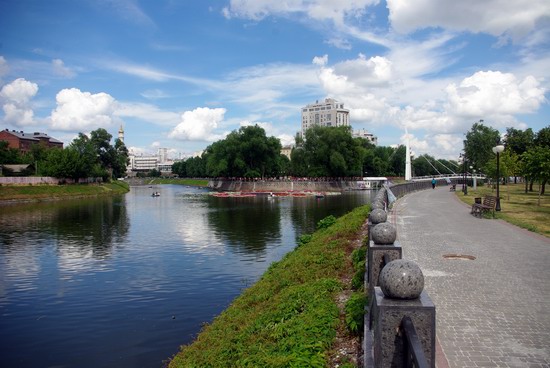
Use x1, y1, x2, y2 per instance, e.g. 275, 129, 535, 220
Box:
51, 88, 116, 131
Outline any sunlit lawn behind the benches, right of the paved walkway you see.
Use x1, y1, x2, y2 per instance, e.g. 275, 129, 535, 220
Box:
456, 184, 550, 237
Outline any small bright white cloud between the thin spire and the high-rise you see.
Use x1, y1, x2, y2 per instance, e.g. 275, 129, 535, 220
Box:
168, 107, 226, 141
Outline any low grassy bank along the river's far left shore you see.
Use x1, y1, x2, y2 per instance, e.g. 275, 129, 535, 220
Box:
0, 181, 130, 201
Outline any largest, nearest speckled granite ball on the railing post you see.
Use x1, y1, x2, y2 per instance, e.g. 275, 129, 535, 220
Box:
378, 259, 424, 299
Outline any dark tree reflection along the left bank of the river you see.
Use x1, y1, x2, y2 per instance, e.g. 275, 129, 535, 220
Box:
0, 196, 130, 259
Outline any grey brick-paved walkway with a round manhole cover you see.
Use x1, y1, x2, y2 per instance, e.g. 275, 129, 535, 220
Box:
390, 187, 550, 368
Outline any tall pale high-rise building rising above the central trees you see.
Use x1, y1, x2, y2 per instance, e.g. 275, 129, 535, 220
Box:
301, 98, 350, 137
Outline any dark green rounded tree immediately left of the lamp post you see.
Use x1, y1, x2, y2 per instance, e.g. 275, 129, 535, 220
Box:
464, 121, 500, 169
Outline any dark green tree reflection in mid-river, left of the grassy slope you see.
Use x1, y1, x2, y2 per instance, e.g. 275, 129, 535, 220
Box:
208, 197, 281, 253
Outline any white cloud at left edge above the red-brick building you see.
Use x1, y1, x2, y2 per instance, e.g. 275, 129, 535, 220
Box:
0, 78, 38, 126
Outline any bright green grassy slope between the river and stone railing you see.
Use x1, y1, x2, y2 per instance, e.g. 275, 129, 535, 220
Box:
169, 206, 369, 368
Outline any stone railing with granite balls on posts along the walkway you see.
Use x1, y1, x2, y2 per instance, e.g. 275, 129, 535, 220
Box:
363, 187, 435, 368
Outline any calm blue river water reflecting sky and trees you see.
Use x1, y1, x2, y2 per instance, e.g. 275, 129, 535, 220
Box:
0, 185, 374, 368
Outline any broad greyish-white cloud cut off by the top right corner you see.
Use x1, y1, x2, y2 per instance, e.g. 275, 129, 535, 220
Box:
387, 0, 550, 38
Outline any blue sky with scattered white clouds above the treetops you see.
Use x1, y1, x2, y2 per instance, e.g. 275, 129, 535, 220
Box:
0, 0, 550, 159
